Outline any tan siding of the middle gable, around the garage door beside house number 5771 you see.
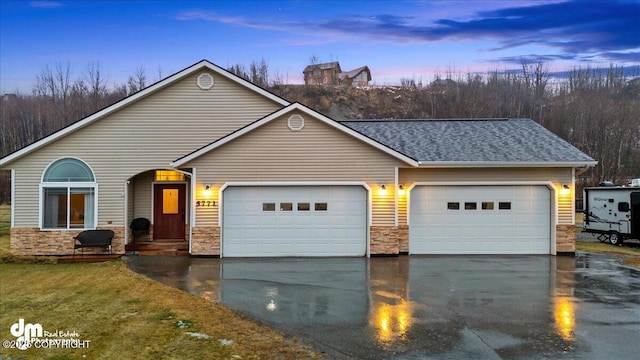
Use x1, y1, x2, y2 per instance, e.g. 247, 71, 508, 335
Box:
185, 114, 402, 226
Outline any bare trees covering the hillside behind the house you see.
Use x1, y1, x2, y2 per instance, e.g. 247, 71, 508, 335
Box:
0, 59, 640, 203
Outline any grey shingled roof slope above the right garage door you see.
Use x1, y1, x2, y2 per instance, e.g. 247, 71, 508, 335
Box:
341, 119, 596, 165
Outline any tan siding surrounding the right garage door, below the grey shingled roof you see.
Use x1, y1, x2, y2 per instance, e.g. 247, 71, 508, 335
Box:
398, 168, 574, 225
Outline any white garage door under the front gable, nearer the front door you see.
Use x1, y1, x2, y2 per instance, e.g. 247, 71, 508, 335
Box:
222, 186, 368, 257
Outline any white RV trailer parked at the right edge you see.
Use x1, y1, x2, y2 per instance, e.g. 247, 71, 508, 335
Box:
582, 186, 640, 245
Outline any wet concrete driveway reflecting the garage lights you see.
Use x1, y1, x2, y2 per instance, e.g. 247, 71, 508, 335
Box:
127, 254, 640, 359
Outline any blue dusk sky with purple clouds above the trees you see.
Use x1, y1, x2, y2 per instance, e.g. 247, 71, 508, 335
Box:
0, 0, 640, 93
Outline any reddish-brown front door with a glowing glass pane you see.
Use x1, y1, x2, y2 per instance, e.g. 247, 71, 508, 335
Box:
153, 184, 187, 240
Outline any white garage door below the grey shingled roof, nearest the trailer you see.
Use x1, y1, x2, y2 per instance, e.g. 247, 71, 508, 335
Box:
409, 186, 551, 254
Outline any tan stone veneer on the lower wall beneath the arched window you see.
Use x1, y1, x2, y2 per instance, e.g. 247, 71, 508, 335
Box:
10, 227, 125, 256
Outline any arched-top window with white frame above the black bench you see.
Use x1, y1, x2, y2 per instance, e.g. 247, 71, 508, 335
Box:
40, 158, 98, 230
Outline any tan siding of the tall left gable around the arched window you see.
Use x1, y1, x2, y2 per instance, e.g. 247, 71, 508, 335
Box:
8, 72, 281, 227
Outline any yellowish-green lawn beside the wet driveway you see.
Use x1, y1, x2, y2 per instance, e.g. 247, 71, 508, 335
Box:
0, 260, 321, 359
